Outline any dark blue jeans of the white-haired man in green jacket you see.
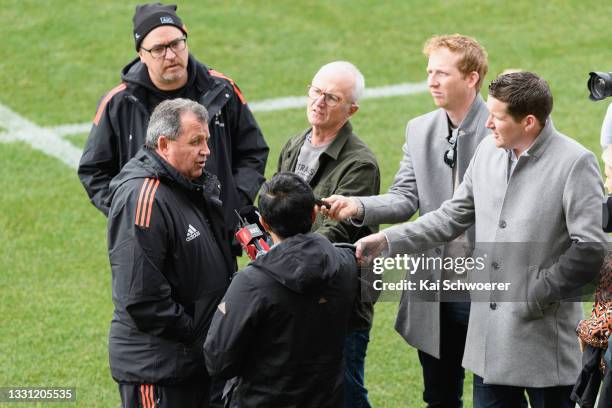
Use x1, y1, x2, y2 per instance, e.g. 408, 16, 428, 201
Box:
344, 330, 371, 408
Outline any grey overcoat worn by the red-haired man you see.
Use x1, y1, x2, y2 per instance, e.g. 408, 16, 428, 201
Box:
359, 94, 489, 358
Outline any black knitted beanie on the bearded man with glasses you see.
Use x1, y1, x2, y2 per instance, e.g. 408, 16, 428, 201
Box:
132, 3, 187, 51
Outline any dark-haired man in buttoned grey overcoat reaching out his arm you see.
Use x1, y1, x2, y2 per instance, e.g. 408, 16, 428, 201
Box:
340, 72, 606, 408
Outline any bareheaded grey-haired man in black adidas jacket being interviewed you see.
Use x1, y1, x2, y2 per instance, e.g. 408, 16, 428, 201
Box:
108, 99, 233, 408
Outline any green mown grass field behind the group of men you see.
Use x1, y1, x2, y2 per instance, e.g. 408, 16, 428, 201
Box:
0, 0, 612, 407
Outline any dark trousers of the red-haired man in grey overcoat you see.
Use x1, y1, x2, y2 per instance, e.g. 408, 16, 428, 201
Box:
418, 310, 467, 408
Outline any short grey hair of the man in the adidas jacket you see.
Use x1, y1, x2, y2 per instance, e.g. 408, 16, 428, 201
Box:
145, 98, 208, 149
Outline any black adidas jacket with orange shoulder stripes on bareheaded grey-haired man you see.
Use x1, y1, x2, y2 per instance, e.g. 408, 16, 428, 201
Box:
108, 148, 233, 384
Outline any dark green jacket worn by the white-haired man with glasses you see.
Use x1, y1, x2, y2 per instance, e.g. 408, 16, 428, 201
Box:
277, 122, 380, 330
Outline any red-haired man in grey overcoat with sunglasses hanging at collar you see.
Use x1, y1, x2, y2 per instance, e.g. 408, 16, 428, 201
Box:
322, 34, 488, 408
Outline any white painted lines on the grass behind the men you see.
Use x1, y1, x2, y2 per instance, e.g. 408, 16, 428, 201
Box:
0, 82, 427, 169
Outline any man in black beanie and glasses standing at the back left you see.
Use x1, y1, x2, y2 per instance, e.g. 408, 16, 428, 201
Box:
78, 3, 268, 255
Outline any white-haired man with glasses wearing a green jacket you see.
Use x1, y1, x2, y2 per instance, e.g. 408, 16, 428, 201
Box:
278, 61, 380, 407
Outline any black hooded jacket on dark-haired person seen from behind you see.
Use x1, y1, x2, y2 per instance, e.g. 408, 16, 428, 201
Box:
204, 233, 358, 408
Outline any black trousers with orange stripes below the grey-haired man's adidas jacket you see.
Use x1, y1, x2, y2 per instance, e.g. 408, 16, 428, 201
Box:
119, 379, 210, 408
